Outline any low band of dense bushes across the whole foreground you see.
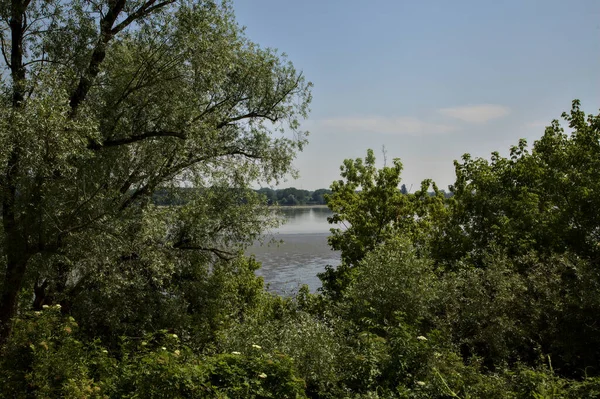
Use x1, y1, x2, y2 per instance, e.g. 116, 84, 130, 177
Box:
0, 250, 600, 398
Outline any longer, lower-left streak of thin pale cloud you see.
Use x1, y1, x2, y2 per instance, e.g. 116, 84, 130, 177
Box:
318, 116, 456, 135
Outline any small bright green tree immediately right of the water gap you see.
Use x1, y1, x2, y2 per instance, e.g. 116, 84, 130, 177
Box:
320, 149, 446, 295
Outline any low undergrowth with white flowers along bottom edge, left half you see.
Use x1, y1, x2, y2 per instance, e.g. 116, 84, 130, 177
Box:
0, 307, 306, 399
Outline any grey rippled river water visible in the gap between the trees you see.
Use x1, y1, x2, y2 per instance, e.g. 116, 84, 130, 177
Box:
247, 207, 340, 295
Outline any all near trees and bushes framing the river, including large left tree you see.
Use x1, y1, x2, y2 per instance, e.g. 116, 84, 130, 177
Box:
0, 0, 600, 399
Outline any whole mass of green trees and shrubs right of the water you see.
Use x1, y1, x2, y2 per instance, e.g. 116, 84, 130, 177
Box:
322, 101, 600, 378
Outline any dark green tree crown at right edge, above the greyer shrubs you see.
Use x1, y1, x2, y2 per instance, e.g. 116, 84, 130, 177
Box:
433, 100, 600, 264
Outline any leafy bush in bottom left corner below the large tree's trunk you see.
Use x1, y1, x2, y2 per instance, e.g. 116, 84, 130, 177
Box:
0, 306, 110, 398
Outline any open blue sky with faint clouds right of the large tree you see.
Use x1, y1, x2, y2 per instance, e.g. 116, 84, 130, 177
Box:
233, 0, 600, 191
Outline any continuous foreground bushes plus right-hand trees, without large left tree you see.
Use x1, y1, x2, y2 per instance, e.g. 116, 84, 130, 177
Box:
0, 103, 600, 399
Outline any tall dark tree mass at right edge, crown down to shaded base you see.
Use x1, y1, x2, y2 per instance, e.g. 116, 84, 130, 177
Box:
429, 100, 600, 377
